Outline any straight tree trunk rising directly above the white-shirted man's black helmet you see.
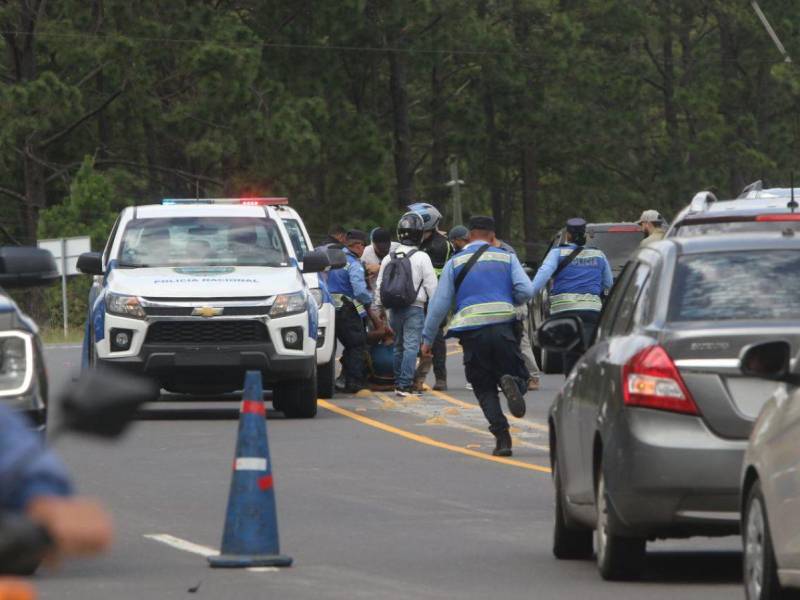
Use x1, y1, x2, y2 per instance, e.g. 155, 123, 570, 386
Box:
389, 52, 414, 210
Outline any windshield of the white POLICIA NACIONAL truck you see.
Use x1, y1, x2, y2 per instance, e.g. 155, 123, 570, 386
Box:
118, 217, 289, 267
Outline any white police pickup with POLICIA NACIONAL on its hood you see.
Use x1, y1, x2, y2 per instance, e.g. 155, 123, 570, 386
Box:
78, 198, 333, 418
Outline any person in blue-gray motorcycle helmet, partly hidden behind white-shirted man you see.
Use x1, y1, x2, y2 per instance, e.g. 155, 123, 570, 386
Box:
408, 202, 453, 391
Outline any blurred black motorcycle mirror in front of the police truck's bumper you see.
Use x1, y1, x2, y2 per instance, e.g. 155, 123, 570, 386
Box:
56, 368, 160, 438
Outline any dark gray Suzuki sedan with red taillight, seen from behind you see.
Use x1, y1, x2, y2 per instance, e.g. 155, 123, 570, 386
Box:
538, 232, 800, 579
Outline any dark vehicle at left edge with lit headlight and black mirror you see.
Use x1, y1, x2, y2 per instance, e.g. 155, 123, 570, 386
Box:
0, 246, 58, 431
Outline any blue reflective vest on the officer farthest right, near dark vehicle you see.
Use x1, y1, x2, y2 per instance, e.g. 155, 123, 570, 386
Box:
550, 245, 607, 314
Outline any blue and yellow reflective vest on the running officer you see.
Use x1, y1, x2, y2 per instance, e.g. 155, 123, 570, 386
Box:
447, 246, 516, 335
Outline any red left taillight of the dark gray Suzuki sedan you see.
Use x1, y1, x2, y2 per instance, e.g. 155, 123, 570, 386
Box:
622, 346, 700, 415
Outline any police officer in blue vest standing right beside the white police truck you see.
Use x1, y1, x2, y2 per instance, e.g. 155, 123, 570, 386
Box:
327, 229, 372, 394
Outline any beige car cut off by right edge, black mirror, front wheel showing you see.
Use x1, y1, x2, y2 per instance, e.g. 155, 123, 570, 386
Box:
741, 340, 800, 600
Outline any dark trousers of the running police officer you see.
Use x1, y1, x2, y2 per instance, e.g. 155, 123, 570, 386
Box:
459, 323, 528, 435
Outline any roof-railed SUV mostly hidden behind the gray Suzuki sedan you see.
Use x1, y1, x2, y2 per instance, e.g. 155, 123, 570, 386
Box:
666, 181, 800, 237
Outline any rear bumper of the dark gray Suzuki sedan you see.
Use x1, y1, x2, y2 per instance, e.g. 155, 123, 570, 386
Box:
603, 408, 747, 537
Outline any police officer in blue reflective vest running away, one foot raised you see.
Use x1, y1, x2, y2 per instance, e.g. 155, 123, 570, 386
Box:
422, 217, 533, 456
